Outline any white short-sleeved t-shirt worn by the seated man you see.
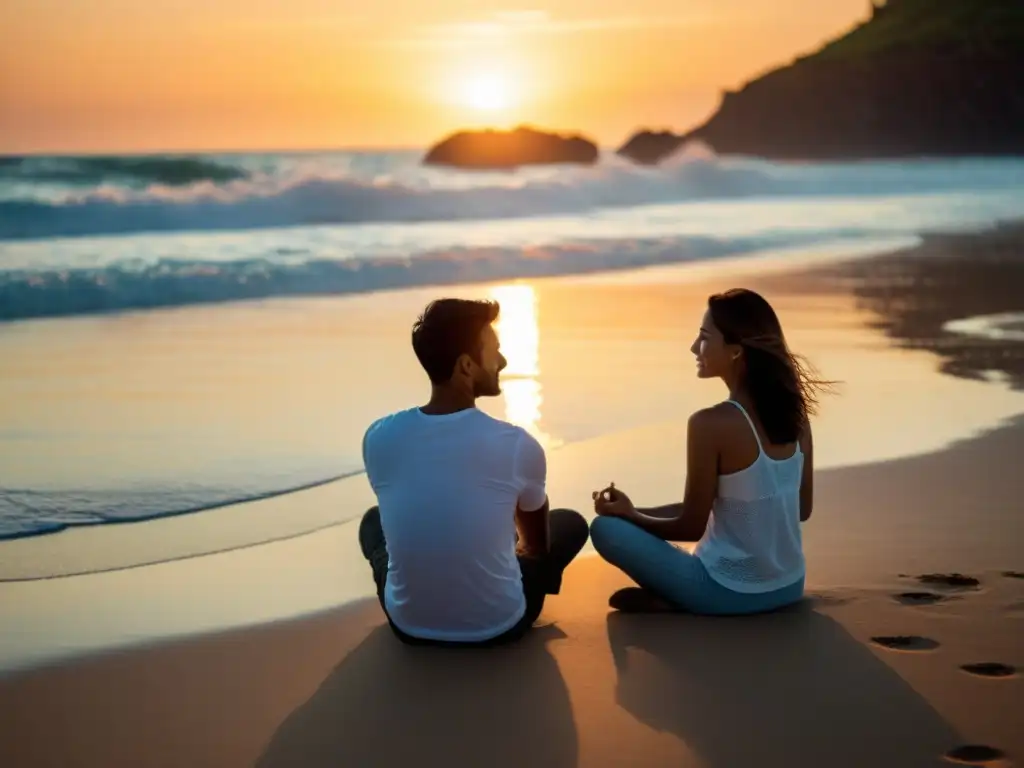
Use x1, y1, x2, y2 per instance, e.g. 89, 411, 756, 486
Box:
362, 408, 547, 642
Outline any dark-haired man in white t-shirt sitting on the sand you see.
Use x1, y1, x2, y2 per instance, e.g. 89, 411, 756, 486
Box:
359, 299, 589, 645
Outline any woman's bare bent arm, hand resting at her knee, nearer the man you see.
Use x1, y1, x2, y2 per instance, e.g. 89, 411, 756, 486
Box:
595, 410, 718, 542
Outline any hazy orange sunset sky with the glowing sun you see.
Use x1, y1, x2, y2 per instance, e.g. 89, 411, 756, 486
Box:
0, 0, 868, 153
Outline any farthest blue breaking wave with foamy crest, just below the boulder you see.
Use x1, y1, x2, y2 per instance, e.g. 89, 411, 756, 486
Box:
0, 158, 1024, 240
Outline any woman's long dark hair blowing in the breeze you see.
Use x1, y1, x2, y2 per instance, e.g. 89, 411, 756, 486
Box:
708, 288, 833, 444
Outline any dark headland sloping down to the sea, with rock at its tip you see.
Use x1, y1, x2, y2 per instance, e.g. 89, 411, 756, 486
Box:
620, 0, 1024, 163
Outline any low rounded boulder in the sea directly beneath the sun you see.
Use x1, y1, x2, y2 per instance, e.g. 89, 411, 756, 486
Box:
423, 127, 600, 170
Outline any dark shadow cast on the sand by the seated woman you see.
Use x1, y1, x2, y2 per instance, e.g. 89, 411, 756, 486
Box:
607, 601, 959, 768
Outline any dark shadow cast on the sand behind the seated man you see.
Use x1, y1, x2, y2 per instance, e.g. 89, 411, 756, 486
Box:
256, 626, 579, 768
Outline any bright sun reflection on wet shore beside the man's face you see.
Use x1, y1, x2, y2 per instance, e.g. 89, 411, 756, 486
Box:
490, 284, 561, 447
